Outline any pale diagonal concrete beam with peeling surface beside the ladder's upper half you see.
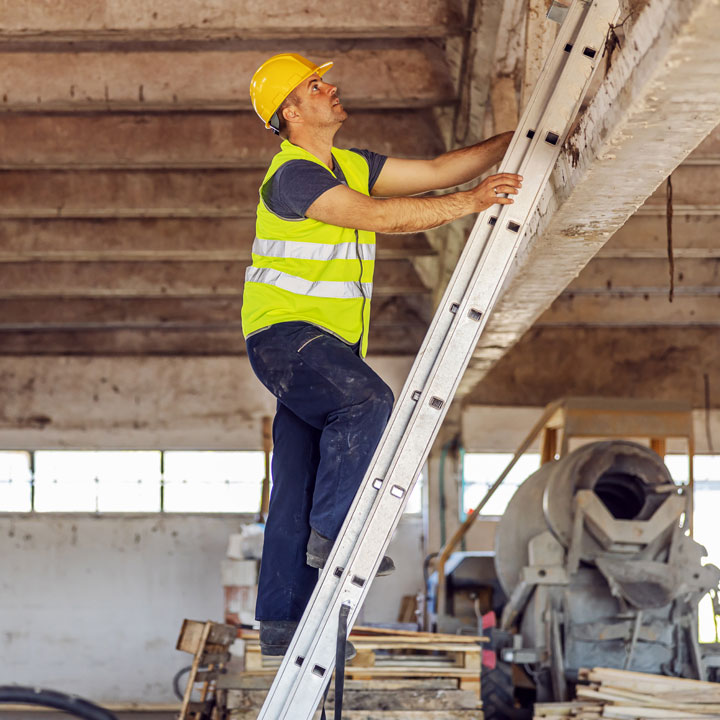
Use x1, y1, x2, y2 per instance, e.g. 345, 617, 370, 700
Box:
458, 0, 720, 402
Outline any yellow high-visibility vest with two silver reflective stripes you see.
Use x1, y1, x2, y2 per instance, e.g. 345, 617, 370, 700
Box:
242, 140, 375, 357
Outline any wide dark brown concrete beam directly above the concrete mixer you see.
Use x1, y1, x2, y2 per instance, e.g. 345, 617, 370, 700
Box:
468, 326, 720, 407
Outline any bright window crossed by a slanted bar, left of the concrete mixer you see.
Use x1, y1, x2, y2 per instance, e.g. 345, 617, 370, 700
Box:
460, 453, 540, 520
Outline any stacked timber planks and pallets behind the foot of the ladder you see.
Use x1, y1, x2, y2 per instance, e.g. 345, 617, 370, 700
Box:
218, 627, 485, 720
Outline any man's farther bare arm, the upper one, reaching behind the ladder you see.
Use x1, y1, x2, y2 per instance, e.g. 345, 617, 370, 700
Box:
372, 132, 513, 197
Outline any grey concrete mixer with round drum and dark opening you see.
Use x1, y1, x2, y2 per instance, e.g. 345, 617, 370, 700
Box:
495, 441, 720, 702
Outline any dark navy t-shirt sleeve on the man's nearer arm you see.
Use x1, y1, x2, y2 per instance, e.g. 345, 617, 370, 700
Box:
261, 160, 342, 220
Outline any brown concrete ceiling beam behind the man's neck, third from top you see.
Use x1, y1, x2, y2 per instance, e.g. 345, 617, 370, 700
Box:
0, 110, 444, 170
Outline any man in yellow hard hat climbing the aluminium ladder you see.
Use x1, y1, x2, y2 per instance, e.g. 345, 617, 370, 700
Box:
242, 54, 522, 655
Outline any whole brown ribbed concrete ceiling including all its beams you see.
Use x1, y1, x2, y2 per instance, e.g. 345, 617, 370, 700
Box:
0, 0, 720, 448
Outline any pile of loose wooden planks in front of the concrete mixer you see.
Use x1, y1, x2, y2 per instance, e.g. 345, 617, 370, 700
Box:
534, 668, 720, 720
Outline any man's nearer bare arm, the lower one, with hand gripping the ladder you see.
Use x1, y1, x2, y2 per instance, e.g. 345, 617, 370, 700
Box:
305, 173, 522, 233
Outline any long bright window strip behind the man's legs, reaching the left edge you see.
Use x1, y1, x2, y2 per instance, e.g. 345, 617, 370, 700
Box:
0, 450, 416, 514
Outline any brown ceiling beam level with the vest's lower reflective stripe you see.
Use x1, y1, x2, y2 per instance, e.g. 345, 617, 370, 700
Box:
0, 260, 426, 298
